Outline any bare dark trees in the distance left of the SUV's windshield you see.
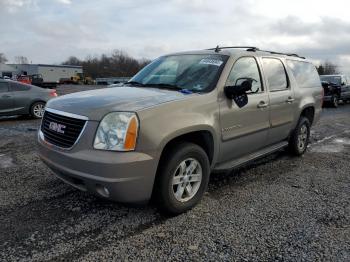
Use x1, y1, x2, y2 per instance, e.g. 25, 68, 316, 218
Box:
62, 50, 151, 78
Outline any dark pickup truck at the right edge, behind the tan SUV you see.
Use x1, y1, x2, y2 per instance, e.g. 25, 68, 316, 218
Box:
320, 75, 350, 107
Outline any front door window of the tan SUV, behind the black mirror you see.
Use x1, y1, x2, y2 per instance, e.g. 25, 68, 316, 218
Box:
226, 57, 263, 94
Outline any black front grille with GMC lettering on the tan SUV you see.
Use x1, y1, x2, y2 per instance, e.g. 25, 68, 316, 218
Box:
41, 111, 86, 149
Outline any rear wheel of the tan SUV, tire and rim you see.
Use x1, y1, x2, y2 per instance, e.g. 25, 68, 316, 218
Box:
289, 117, 311, 156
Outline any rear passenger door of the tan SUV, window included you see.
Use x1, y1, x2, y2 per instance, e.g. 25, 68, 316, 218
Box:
262, 57, 295, 144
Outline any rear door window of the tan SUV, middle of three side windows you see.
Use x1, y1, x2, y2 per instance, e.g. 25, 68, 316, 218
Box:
263, 58, 288, 91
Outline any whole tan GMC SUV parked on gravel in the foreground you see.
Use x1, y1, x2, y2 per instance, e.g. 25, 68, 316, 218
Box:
38, 47, 323, 214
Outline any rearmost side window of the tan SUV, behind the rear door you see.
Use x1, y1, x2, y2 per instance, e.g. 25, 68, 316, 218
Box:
287, 60, 321, 88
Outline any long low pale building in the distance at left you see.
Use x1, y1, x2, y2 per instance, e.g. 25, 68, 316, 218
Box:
7, 64, 83, 82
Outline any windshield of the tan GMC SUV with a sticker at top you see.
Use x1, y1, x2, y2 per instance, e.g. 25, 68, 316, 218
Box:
129, 55, 228, 92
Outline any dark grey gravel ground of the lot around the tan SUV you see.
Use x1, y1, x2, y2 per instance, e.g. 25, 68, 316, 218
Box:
0, 86, 350, 261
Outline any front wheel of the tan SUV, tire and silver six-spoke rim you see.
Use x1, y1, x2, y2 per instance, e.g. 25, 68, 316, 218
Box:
155, 143, 210, 215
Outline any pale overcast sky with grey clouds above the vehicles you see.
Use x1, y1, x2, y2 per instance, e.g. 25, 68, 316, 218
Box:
0, 0, 350, 73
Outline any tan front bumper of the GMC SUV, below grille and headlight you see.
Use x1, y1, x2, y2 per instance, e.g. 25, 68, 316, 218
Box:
38, 121, 158, 203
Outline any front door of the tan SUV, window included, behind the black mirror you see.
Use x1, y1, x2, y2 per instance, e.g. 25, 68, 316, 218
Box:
219, 57, 270, 162
